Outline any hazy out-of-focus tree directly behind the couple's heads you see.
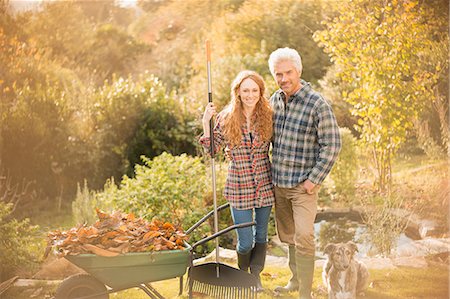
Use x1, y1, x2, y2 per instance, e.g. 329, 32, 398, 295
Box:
183, 0, 331, 111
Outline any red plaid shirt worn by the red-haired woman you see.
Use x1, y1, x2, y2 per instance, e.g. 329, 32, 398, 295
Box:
200, 114, 275, 210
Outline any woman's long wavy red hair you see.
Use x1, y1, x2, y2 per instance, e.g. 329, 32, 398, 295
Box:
223, 71, 273, 147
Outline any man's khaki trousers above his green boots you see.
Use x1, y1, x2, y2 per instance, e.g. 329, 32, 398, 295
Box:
275, 183, 318, 256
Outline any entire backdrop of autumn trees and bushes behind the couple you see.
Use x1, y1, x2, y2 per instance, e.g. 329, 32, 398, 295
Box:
0, 0, 449, 280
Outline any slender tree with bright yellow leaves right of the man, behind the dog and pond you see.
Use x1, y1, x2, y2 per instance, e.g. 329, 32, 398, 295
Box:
315, 0, 437, 191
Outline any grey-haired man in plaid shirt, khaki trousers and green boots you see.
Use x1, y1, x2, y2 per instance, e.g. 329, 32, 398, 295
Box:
268, 48, 341, 299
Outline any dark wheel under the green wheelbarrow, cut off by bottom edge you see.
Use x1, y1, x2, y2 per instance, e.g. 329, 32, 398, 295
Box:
55, 274, 109, 299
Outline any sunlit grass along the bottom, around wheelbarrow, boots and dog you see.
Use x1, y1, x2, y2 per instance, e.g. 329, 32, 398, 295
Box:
7, 265, 449, 299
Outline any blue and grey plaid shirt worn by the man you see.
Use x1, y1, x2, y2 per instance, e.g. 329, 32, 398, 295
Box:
270, 80, 341, 188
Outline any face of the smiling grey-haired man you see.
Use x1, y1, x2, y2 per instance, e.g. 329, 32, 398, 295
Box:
274, 60, 301, 98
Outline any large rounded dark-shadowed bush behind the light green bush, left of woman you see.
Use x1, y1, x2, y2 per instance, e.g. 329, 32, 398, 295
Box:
86, 73, 196, 181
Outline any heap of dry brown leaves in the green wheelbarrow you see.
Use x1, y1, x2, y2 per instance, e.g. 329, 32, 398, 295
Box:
45, 209, 188, 256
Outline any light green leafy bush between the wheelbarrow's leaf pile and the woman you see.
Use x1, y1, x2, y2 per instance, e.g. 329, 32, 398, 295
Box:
90, 153, 226, 252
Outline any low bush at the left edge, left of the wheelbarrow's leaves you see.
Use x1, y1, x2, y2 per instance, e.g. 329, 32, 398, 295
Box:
0, 202, 38, 281
